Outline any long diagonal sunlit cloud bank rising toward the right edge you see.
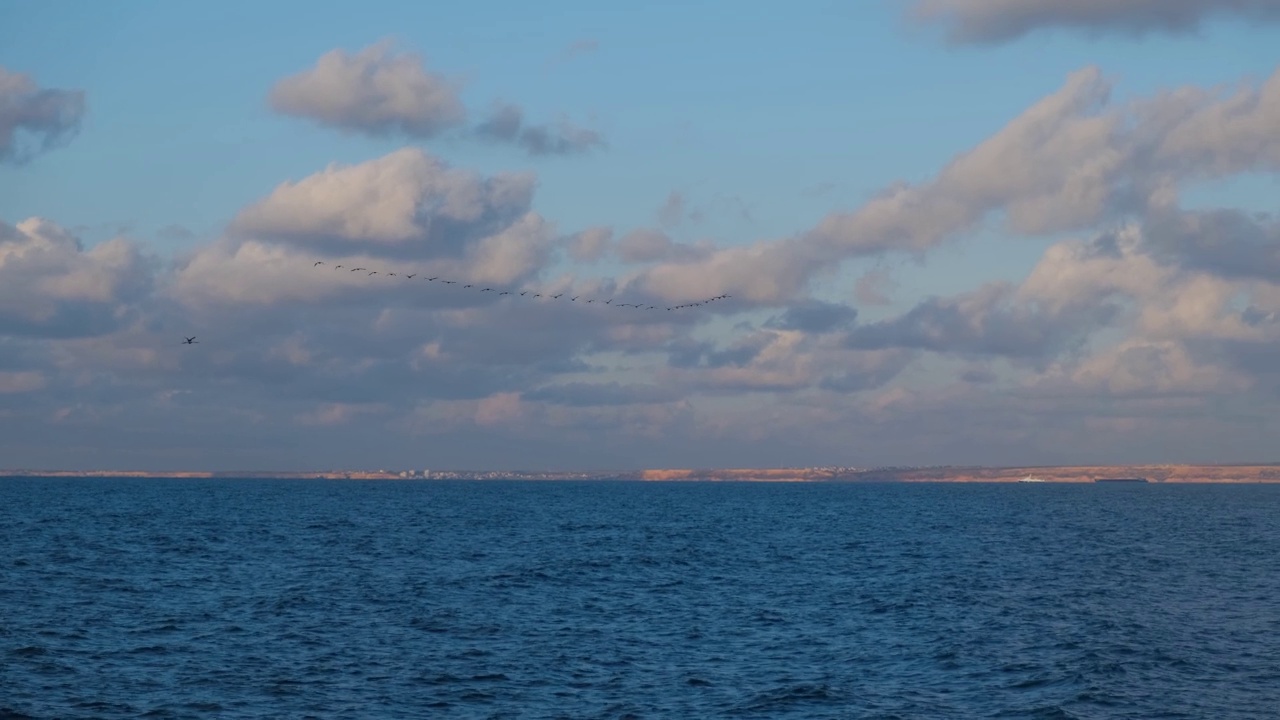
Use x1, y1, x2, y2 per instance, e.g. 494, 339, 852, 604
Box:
806, 67, 1280, 266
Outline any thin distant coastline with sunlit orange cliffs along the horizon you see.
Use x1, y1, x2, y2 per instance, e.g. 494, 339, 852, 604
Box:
0, 462, 1280, 484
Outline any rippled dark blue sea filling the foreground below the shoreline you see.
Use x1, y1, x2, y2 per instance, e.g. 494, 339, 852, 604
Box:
0, 478, 1280, 719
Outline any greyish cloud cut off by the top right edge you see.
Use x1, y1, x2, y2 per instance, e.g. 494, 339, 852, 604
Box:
909, 0, 1280, 45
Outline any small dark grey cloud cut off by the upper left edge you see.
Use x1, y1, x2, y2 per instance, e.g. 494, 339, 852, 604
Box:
0, 67, 84, 165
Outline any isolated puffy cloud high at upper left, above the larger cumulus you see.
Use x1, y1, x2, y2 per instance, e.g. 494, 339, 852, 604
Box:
268, 41, 466, 140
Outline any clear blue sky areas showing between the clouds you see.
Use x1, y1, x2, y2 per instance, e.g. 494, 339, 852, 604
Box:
0, 0, 1276, 466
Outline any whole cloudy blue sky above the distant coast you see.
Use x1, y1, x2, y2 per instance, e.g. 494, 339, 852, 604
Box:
0, 0, 1280, 471
